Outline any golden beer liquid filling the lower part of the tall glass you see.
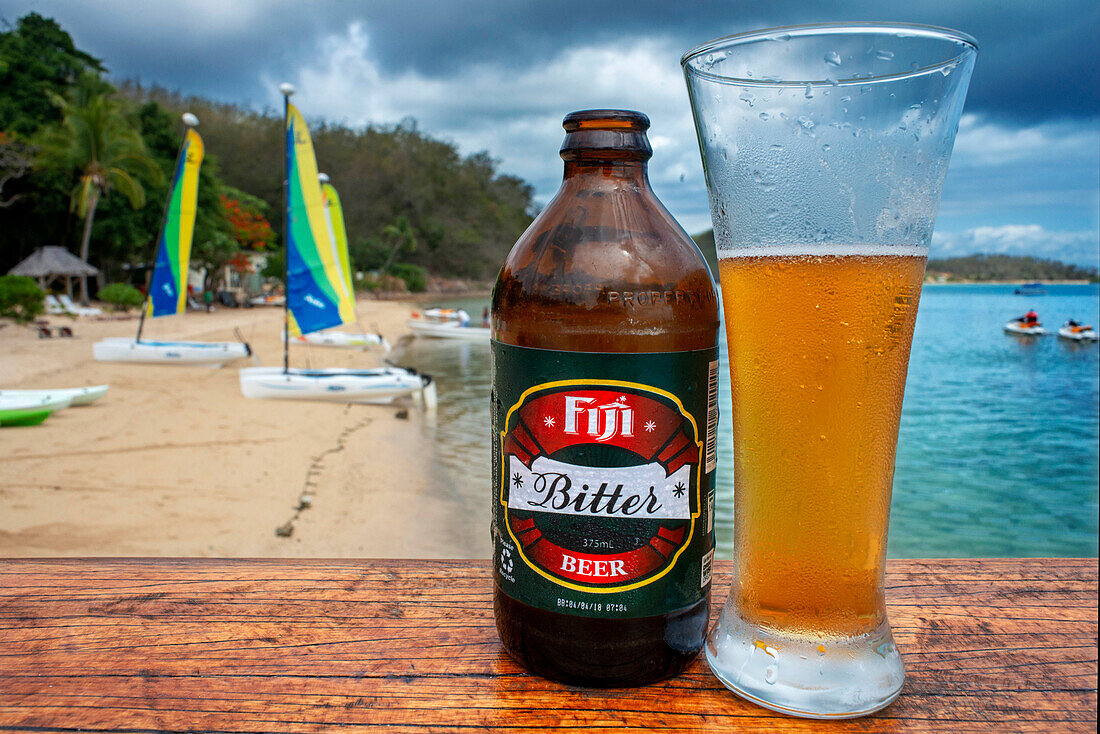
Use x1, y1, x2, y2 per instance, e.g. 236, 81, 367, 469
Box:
719, 247, 927, 637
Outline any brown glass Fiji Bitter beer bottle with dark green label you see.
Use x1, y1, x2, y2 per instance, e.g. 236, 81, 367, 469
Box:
491, 110, 718, 686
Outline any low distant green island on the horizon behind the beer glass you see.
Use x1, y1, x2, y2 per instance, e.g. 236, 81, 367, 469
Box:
692, 230, 1100, 283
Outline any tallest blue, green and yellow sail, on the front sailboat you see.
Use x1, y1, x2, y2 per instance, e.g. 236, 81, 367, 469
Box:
286, 101, 355, 336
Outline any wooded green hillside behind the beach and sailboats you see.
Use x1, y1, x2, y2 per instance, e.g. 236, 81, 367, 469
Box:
0, 13, 534, 286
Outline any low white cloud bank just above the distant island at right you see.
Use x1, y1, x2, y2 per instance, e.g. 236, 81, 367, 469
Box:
932, 224, 1100, 267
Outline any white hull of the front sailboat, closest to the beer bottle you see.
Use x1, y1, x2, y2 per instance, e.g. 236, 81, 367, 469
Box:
240, 368, 435, 407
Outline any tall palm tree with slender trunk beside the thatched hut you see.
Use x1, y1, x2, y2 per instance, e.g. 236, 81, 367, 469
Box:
39, 77, 162, 304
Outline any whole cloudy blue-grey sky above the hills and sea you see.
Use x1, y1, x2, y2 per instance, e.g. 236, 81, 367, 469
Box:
0, 0, 1100, 266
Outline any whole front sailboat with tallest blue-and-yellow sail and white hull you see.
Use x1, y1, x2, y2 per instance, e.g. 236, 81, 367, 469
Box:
240, 84, 436, 407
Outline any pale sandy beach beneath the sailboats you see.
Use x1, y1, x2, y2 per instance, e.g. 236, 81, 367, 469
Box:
0, 300, 488, 558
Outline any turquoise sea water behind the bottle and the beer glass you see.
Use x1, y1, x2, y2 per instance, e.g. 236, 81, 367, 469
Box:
394, 285, 1100, 558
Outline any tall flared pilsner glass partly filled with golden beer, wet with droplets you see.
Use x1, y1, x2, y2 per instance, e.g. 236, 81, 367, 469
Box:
682, 24, 977, 719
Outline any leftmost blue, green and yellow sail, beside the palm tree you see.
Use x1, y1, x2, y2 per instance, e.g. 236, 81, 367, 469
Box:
146, 128, 204, 317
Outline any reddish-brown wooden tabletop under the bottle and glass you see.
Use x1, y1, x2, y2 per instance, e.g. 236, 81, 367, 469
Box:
0, 559, 1097, 732
